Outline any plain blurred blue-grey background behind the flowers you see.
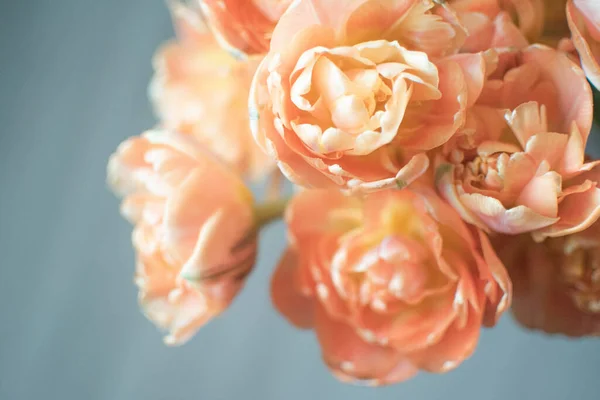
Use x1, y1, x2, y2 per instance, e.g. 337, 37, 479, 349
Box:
0, 0, 600, 400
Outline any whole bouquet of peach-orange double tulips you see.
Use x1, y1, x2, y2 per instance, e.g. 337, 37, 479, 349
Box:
108, 0, 600, 385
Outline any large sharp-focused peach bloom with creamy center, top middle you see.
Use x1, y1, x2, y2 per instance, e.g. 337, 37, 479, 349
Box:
250, 0, 495, 191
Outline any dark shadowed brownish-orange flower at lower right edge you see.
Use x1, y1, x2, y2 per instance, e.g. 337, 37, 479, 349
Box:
494, 231, 600, 337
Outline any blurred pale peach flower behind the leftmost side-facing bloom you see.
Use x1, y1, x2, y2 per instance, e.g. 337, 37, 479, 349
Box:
150, 1, 274, 179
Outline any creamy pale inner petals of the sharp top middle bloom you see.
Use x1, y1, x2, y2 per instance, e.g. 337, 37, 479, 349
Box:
288, 41, 441, 156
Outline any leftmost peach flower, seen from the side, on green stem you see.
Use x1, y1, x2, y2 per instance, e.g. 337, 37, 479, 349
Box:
108, 131, 256, 345
